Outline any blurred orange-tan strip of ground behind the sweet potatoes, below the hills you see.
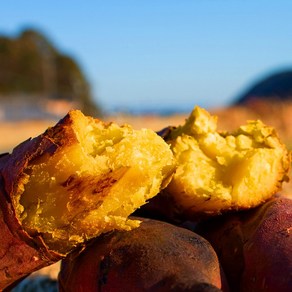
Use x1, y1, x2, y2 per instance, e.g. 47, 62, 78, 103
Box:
0, 103, 292, 153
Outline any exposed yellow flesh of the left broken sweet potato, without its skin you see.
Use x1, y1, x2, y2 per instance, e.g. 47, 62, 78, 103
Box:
16, 111, 174, 252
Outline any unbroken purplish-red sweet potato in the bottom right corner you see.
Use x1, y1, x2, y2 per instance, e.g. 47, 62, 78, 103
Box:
199, 197, 292, 292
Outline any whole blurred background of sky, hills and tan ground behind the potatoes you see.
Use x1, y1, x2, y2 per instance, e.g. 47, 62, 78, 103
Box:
0, 0, 292, 148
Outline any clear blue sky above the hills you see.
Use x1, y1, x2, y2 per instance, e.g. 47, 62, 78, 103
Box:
0, 0, 292, 110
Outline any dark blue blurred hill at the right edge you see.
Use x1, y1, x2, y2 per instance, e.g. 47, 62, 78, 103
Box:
234, 69, 292, 105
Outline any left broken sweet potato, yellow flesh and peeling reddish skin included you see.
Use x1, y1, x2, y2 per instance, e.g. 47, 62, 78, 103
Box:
0, 111, 174, 289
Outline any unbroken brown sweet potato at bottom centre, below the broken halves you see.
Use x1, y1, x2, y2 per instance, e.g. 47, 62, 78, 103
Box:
59, 219, 228, 292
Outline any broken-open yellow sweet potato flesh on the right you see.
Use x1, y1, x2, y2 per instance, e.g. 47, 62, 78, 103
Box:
165, 107, 290, 214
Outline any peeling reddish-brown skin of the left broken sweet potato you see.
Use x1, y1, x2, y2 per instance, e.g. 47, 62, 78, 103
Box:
0, 114, 75, 290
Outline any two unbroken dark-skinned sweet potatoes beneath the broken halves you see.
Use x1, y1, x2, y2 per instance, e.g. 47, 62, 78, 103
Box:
59, 197, 292, 292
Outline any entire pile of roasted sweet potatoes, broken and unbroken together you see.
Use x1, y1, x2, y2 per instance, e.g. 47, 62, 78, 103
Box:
0, 109, 292, 292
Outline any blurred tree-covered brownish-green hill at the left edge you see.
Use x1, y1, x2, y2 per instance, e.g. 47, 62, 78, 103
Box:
0, 29, 101, 116
